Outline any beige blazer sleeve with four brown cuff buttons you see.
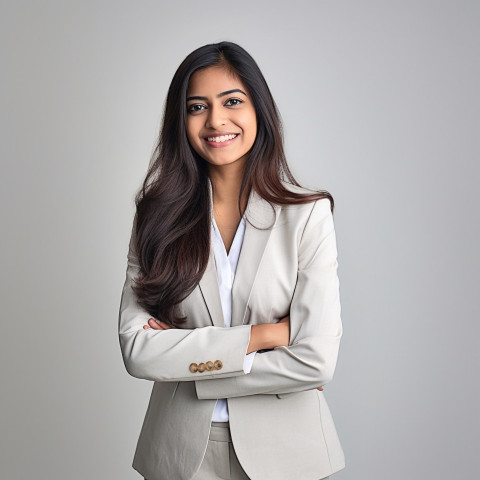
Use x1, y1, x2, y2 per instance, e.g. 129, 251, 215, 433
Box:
118, 217, 251, 382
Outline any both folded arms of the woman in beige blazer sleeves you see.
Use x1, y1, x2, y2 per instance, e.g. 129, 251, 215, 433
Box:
119, 199, 342, 399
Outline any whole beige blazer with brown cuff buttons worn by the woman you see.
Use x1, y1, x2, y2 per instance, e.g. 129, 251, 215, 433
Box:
119, 183, 345, 480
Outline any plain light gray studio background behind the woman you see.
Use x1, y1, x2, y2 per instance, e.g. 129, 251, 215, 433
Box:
0, 0, 480, 480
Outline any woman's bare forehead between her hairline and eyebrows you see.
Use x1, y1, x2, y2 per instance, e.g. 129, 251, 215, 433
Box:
188, 66, 246, 96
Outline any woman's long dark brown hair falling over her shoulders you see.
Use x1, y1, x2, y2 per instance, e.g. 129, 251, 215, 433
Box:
134, 42, 334, 326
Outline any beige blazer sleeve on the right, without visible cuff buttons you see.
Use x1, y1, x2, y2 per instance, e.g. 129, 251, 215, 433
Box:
195, 199, 343, 399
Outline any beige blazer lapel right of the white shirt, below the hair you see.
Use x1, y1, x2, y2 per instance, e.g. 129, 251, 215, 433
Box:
232, 191, 281, 327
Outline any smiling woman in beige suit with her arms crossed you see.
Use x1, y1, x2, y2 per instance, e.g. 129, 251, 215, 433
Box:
119, 42, 344, 480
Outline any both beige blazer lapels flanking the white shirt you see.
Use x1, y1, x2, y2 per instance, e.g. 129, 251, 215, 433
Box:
199, 180, 281, 327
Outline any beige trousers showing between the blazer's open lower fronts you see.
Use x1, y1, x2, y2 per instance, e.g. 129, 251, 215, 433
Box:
145, 422, 329, 480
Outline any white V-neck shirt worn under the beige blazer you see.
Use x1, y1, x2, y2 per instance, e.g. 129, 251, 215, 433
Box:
211, 216, 256, 422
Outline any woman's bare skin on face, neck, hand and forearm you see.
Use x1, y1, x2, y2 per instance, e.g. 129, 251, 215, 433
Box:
143, 66, 323, 390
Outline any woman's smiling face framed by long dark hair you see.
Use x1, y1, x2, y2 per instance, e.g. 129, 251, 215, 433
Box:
187, 66, 257, 171
